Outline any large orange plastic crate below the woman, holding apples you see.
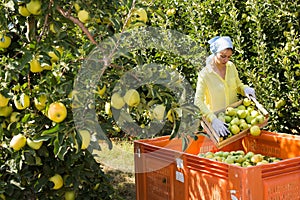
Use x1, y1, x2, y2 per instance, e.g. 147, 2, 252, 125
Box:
134, 131, 300, 200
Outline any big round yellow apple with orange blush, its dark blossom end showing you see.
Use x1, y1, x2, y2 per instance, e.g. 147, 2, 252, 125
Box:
47, 102, 67, 123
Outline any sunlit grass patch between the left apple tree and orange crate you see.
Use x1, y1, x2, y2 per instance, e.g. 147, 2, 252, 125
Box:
94, 141, 136, 200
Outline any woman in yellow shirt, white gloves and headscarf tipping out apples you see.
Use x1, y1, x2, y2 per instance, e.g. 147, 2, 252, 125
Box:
195, 36, 255, 136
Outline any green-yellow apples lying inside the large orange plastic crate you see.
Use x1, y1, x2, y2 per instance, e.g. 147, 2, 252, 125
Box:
198, 150, 281, 167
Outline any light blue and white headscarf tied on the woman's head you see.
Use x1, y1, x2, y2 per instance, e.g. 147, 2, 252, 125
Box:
206, 36, 233, 69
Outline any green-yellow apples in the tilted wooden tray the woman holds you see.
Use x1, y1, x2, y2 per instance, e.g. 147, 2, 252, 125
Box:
217, 98, 265, 139
